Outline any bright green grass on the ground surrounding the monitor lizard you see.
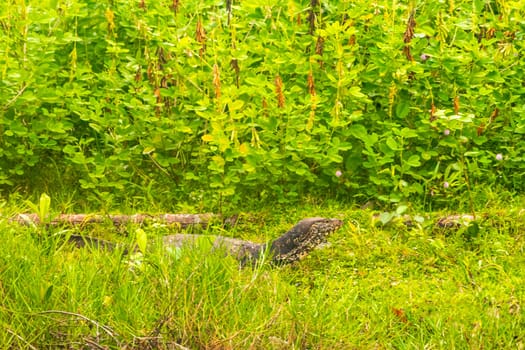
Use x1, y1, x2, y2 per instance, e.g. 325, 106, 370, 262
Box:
0, 200, 525, 349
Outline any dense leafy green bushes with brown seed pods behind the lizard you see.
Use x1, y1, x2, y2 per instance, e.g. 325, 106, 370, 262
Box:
0, 0, 525, 206
